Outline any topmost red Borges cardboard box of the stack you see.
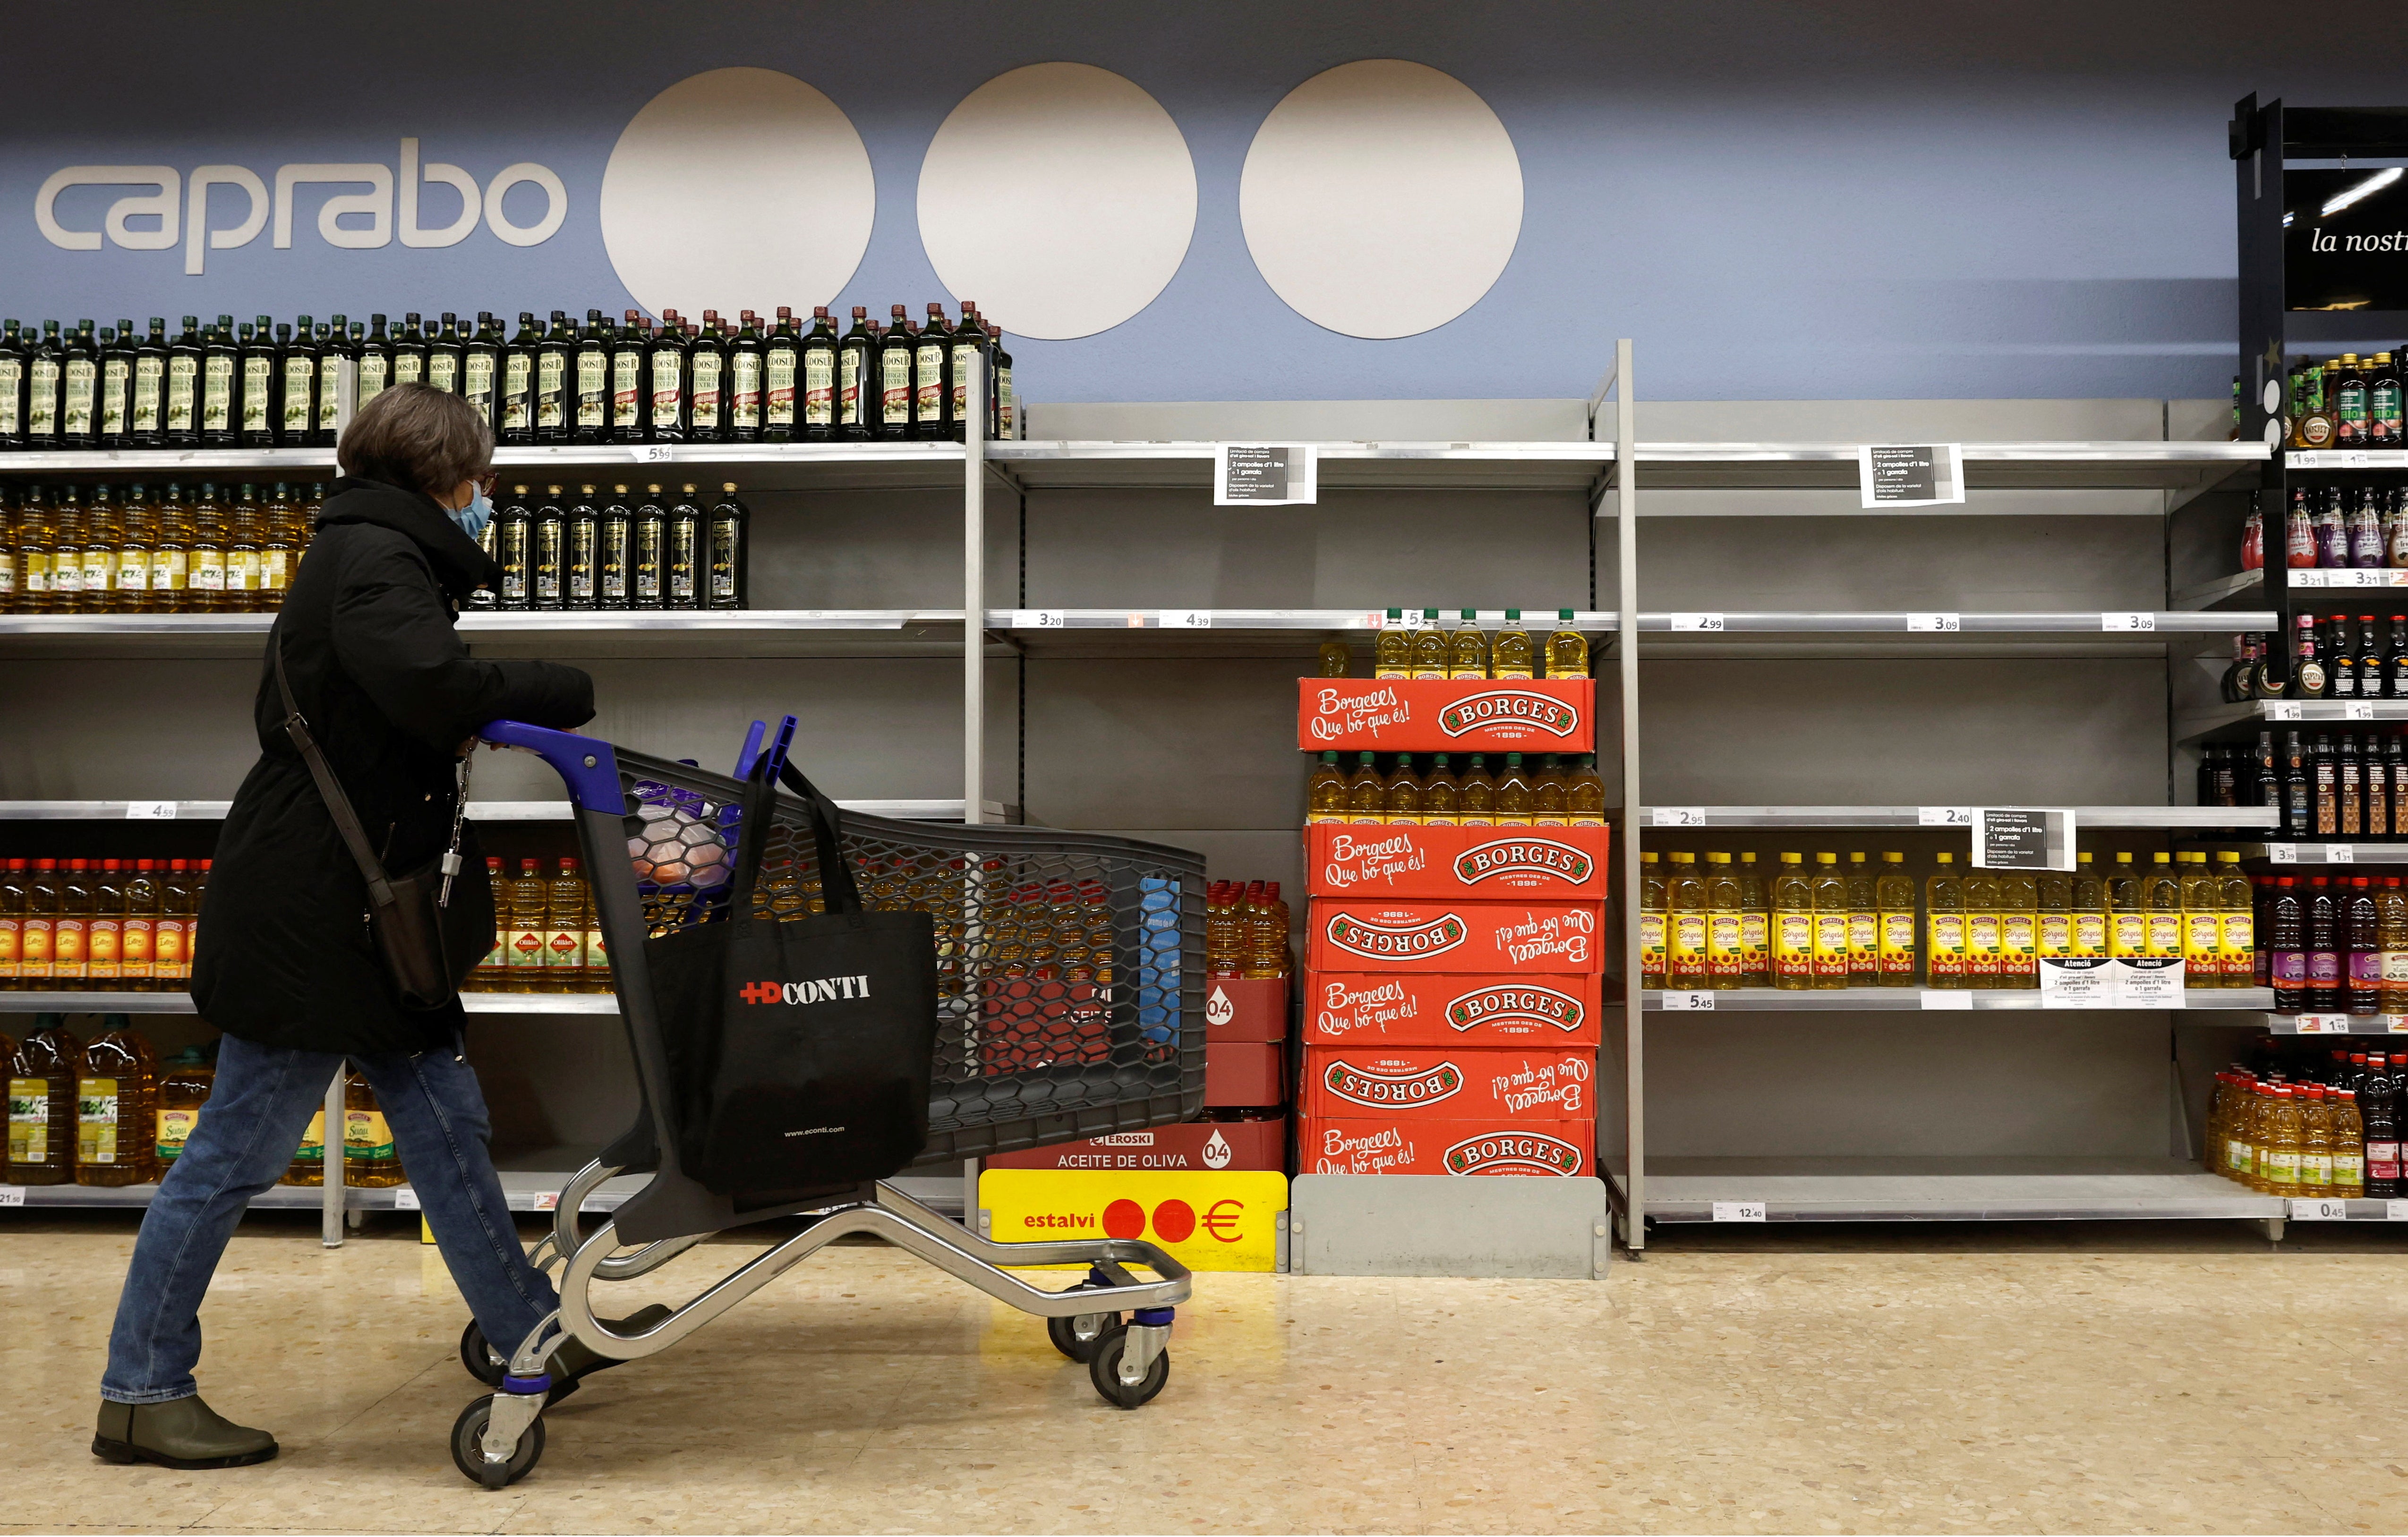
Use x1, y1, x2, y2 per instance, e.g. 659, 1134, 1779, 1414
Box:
1296, 677, 1597, 751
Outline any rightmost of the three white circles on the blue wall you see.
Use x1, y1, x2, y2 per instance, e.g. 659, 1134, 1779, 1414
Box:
1238, 58, 1522, 337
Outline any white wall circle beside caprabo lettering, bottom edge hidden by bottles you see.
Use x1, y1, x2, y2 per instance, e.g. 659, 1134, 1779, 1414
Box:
599, 68, 877, 316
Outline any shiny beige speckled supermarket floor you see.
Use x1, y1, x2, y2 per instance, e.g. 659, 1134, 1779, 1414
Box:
0, 1212, 2408, 1532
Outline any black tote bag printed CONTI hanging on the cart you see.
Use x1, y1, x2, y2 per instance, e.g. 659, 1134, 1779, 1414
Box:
645, 754, 937, 1204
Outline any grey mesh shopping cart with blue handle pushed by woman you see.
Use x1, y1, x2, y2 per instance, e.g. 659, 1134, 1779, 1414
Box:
453, 720, 1204, 1489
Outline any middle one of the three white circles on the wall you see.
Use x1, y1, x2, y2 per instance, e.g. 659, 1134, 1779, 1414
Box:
920, 63, 1197, 342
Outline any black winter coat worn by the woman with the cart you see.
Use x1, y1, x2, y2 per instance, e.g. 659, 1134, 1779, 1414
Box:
193, 477, 595, 1053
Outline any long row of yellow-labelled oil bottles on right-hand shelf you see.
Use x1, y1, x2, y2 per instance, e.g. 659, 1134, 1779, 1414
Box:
1640, 850, 2261, 990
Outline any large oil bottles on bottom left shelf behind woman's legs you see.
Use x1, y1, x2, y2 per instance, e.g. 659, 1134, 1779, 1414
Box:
0, 1014, 404, 1190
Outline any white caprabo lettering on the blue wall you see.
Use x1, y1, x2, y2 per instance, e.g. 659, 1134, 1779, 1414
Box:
34, 140, 568, 277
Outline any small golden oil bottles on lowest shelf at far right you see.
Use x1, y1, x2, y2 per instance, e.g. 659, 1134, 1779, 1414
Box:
2201, 1036, 2408, 1200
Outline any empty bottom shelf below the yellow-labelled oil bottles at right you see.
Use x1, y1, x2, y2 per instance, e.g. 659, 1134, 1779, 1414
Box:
1618, 1156, 2285, 1221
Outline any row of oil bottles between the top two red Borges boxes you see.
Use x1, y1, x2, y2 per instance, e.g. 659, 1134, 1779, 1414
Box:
1305, 751, 1606, 826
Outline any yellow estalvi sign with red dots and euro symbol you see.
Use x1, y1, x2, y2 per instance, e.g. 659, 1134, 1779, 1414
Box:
978, 1169, 1288, 1270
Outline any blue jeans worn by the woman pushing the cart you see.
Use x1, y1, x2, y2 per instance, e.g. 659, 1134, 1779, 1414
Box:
101, 1036, 559, 1404
